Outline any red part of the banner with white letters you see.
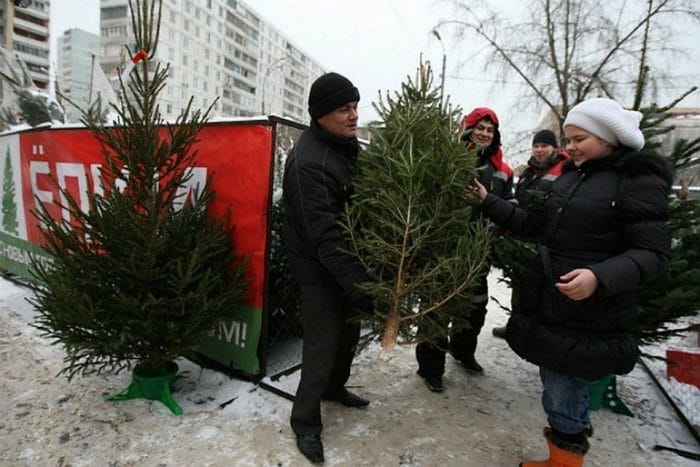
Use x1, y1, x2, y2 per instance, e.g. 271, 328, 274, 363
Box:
19, 123, 272, 309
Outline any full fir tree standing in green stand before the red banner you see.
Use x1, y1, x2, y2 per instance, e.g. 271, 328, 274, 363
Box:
31, 0, 244, 379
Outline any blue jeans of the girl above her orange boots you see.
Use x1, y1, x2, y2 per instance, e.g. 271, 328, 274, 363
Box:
540, 367, 591, 434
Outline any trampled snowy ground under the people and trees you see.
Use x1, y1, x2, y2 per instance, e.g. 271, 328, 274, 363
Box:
0, 274, 700, 467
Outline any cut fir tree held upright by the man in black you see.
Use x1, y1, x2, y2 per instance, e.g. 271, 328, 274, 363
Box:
344, 63, 490, 350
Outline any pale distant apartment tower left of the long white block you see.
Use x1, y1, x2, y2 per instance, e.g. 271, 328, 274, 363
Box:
56, 29, 100, 122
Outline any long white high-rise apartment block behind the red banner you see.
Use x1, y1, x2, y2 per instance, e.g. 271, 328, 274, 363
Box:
100, 0, 324, 122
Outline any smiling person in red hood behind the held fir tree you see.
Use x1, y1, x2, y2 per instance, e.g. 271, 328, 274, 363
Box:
416, 107, 513, 392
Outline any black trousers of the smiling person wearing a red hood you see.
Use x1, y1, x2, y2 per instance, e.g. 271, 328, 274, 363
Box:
416, 273, 489, 377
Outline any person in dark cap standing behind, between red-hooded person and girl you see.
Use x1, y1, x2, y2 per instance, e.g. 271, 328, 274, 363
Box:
492, 129, 569, 339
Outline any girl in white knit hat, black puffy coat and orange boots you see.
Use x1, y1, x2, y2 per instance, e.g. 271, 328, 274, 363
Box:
465, 98, 671, 466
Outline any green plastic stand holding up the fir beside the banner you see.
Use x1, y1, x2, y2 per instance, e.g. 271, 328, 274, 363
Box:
105, 362, 182, 415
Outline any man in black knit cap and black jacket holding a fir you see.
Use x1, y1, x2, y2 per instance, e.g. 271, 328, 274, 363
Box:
283, 73, 373, 463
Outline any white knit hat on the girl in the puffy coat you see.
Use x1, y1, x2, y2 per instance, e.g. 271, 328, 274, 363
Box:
564, 97, 644, 150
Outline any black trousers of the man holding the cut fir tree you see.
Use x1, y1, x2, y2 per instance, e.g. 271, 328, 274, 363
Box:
290, 282, 360, 434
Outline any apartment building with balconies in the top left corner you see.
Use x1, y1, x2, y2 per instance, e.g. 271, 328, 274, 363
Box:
0, 0, 51, 90
